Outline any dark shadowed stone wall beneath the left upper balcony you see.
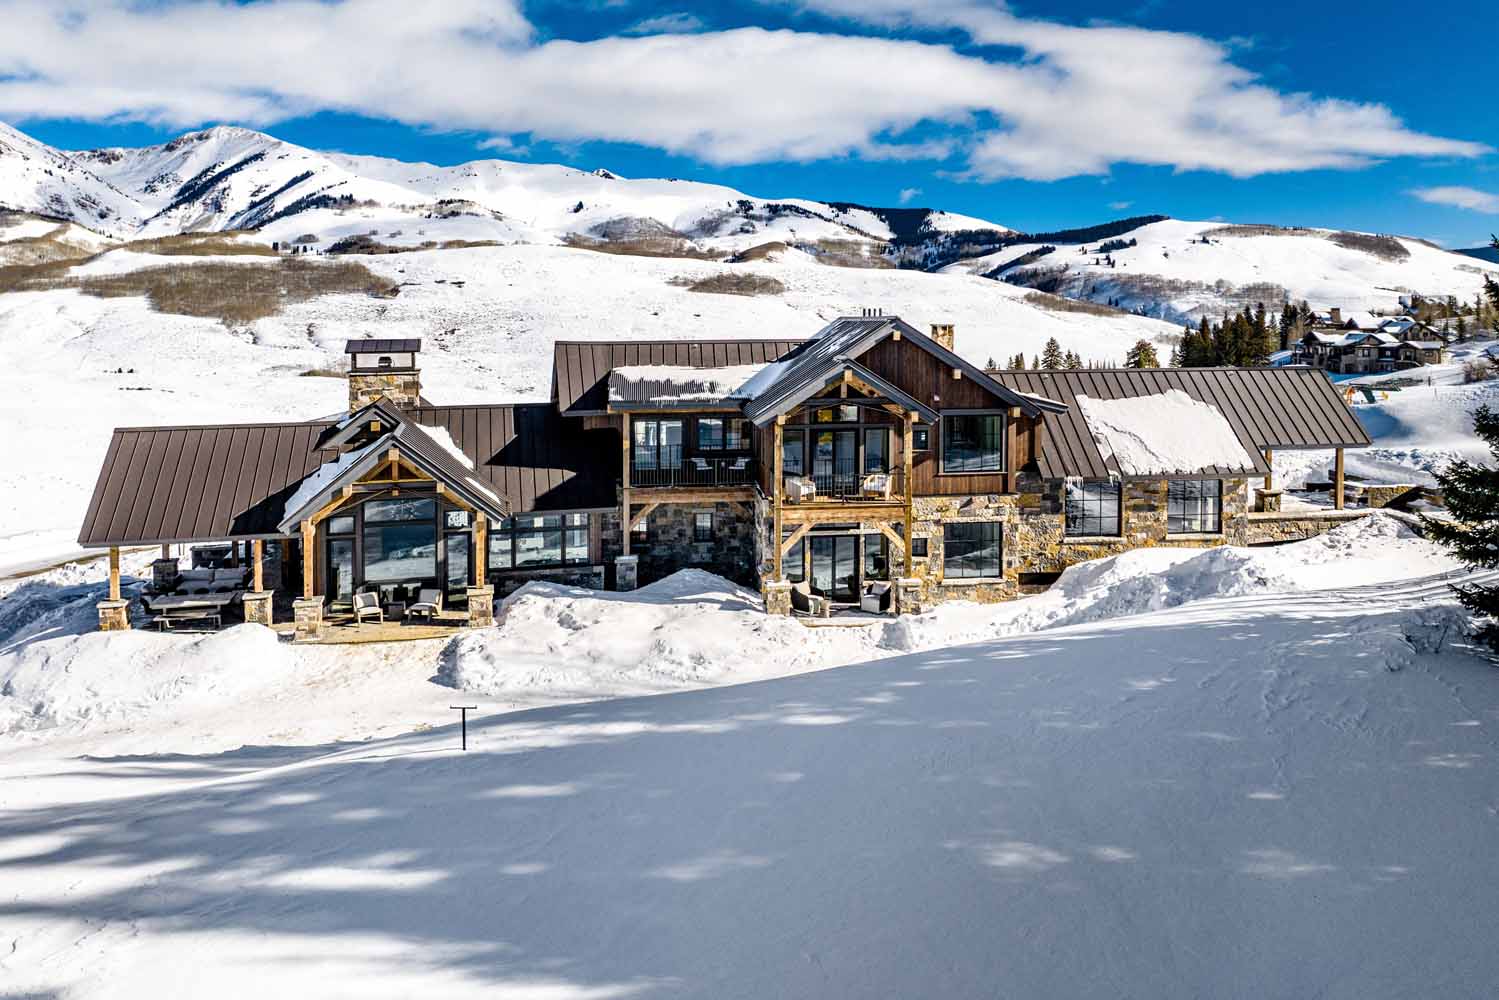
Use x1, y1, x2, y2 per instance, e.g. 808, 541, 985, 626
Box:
623, 501, 761, 586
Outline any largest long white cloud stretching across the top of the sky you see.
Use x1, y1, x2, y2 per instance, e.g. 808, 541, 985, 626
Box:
0, 0, 1486, 180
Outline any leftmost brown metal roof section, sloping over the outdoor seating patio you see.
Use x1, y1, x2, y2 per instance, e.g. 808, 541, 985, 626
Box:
78, 423, 328, 547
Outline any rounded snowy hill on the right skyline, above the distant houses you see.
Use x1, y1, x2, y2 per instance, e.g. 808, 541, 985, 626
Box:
946, 219, 1499, 322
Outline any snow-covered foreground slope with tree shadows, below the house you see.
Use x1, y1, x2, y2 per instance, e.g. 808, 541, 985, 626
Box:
0, 516, 1499, 997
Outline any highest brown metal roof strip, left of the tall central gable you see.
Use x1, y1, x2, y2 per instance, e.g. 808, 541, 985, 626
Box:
554, 339, 803, 413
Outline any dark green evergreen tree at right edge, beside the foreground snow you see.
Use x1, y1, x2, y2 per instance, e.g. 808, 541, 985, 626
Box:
1421, 406, 1499, 649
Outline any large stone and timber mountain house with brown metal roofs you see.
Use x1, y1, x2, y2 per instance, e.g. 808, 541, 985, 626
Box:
79, 315, 1369, 639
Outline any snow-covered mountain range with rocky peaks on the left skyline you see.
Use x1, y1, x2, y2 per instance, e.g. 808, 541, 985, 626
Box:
0, 126, 1009, 253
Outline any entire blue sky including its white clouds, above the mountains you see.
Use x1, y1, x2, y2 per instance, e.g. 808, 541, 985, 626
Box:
11, 0, 1499, 246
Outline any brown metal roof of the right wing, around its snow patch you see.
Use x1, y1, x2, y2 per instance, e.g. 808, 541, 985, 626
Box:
992, 367, 1370, 478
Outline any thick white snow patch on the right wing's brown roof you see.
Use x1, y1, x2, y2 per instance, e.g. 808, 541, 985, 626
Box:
1076, 388, 1255, 475
